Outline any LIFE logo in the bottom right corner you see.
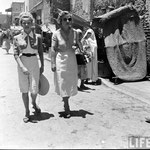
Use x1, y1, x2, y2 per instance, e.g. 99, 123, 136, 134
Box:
128, 136, 150, 149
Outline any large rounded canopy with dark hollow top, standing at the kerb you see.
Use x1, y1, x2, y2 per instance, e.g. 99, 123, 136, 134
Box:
92, 6, 147, 81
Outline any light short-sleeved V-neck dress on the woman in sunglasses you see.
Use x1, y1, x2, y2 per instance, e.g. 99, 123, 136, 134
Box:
52, 29, 78, 97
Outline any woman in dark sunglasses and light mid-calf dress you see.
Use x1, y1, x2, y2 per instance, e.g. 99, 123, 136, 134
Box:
51, 11, 82, 118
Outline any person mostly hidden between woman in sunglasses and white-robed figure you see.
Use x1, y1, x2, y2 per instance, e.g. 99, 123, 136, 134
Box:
76, 29, 88, 91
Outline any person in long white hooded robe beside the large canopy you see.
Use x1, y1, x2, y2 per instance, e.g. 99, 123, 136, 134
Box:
82, 29, 98, 85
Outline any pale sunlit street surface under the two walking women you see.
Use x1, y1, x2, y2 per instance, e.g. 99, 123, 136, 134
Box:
0, 49, 150, 149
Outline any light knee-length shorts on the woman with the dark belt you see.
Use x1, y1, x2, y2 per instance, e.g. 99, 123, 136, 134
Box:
18, 56, 40, 94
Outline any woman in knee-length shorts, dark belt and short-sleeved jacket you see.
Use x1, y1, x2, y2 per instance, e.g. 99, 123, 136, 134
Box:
13, 12, 44, 123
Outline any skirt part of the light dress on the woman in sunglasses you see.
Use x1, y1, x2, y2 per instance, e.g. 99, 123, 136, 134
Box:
54, 51, 78, 97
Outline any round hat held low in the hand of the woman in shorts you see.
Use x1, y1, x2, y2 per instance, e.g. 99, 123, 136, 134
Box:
38, 74, 50, 96
